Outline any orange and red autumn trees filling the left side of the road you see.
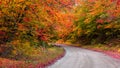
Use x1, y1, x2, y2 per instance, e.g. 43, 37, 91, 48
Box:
0, 0, 74, 59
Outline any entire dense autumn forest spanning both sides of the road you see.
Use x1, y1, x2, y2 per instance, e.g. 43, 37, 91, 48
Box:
0, 0, 120, 67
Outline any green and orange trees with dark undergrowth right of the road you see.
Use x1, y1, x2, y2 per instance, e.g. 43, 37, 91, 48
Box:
72, 0, 120, 44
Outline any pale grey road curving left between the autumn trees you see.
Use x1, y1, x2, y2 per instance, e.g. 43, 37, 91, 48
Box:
47, 46, 120, 68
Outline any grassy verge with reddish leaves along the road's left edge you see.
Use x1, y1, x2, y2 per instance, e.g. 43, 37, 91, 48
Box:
0, 46, 65, 68
